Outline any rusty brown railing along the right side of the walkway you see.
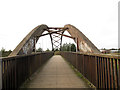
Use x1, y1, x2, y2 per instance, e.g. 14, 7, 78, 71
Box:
61, 52, 120, 88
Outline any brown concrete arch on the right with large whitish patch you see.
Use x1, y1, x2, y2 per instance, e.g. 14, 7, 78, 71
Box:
64, 24, 100, 53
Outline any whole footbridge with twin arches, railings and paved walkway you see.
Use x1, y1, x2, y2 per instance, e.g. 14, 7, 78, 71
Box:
0, 24, 120, 89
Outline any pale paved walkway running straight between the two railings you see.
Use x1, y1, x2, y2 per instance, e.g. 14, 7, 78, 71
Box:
25, 55, 89, 88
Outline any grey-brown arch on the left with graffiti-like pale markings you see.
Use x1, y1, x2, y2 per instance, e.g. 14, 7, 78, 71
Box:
9, 25, 48, 56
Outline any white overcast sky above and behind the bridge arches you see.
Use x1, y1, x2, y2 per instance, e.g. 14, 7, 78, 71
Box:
0, 0, 119, 50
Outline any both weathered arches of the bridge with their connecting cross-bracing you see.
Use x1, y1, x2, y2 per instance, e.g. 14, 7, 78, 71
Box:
9, 24, 100, 56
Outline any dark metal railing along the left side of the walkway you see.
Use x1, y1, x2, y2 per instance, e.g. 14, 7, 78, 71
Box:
0, 52, 54, 89
